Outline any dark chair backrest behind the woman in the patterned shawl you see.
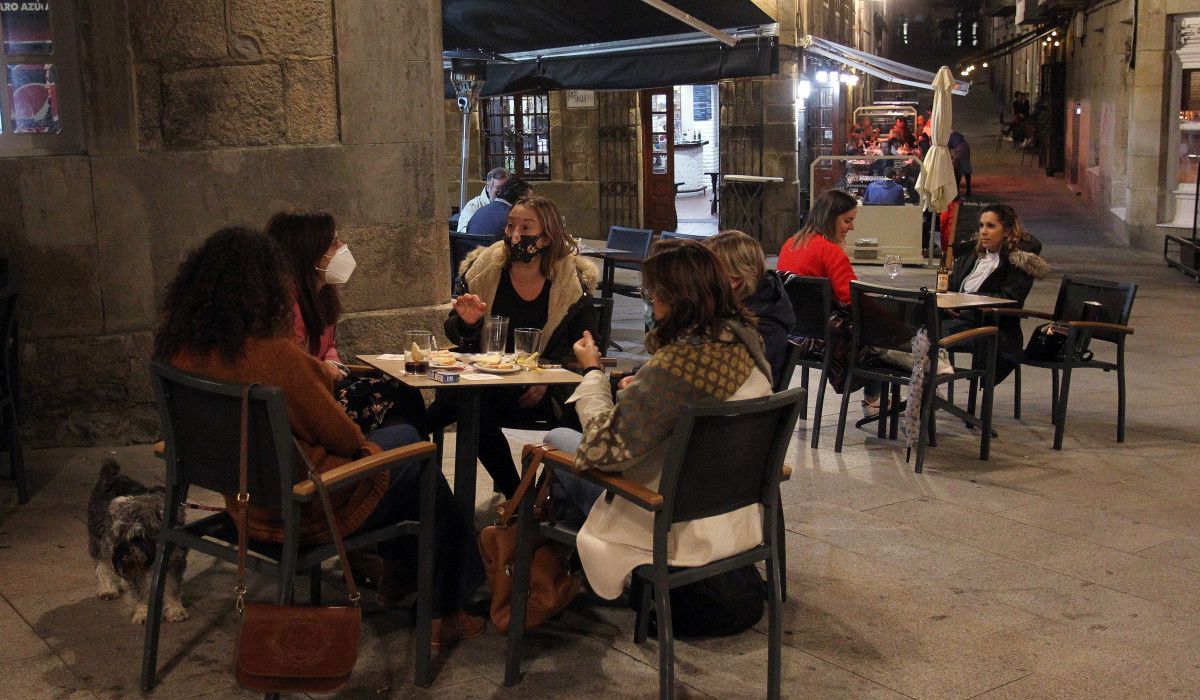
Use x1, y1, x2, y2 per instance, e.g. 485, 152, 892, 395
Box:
659, 388, 804, 523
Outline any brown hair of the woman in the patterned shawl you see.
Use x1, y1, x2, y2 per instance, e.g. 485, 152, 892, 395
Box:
642, 239, 754, 348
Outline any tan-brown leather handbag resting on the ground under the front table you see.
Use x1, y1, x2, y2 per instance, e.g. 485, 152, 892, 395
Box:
479, 445, 583, 634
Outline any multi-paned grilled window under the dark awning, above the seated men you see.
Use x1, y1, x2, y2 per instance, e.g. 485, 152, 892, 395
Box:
480, 92, 550, 180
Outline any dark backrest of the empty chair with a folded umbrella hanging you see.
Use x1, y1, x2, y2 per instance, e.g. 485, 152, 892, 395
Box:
850, 280, 938, 358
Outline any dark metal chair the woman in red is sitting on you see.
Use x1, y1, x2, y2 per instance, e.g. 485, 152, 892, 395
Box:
784, 275, 834, 449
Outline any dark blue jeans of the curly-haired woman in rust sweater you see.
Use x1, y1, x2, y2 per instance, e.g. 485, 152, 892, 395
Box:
362, 424, 484, 617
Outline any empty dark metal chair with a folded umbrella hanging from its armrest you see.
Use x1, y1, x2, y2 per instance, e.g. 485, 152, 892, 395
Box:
834, 281, 997, 473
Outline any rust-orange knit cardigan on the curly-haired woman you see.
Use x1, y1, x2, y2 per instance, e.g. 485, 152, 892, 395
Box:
170, 336, 388, 544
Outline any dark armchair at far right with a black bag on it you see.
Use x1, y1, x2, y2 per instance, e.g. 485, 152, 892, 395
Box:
988, 277, 1138, 449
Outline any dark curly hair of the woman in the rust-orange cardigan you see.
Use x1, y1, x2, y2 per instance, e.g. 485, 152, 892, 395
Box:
154, 228, 292, 361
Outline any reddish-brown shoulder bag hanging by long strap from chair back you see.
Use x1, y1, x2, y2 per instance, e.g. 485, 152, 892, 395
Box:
234, 384, 362, 693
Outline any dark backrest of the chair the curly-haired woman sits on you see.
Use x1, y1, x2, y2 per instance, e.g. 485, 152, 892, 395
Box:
149, 361, 300, 511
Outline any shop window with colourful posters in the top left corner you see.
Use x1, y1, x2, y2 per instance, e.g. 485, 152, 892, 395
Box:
0, 0, 83, 156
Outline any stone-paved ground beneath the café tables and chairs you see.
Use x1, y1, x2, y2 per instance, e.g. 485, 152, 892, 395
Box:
0, 92, 1200, 698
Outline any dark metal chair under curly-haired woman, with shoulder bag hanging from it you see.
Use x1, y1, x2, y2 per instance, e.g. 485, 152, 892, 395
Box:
142, 361, 439, 693
